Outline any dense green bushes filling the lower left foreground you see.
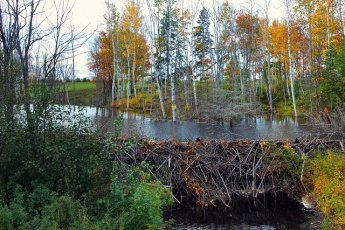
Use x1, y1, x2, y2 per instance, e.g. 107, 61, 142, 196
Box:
0, 98, 172, 230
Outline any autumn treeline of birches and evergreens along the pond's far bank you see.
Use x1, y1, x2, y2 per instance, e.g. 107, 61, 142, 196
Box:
89, 0, 345, 119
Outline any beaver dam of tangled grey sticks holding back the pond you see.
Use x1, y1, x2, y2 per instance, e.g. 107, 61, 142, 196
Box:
113, 139, 344, 207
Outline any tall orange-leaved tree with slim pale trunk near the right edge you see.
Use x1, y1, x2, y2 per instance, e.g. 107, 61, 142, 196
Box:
295, 0, 343, 111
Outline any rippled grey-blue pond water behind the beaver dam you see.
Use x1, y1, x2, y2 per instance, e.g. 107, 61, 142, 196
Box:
70, 107, 310, 140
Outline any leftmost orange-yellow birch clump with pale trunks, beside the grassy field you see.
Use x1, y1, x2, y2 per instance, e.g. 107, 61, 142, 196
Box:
88, 2, 149, 109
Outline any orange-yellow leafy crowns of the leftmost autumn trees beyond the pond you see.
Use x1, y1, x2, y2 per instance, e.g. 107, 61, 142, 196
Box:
88, 2, 150, 85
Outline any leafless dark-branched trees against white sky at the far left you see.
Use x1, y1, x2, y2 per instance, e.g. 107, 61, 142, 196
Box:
0, 0, 86, 122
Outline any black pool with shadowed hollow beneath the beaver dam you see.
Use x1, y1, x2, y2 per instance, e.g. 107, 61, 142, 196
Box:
165, 199, 320, 230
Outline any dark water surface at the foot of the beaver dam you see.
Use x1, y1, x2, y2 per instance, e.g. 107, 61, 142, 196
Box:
171, 209, 319, 230
